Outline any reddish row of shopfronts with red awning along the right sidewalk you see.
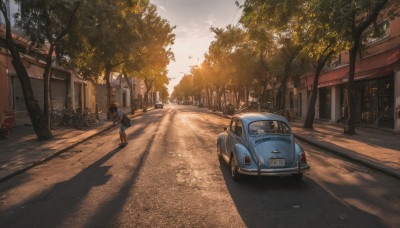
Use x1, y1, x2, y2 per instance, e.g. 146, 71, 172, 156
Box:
285, 17, 400, 132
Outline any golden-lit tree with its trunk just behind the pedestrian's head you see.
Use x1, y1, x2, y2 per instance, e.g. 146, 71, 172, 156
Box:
65, 0, 148, 118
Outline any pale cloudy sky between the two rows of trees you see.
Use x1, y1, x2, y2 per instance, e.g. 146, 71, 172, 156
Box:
151, 0, 241, 94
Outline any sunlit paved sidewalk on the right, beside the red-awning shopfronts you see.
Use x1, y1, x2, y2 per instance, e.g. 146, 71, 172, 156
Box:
206, 108, 400, 179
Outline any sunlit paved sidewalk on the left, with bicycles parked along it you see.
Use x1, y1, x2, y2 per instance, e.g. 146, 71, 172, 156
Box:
0, 108, 151, 183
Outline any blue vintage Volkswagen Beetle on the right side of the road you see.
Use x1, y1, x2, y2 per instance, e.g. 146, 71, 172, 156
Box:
217, 113, 310, 181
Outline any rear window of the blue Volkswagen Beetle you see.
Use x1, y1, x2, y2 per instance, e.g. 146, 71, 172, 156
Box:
249, 120, 290, 136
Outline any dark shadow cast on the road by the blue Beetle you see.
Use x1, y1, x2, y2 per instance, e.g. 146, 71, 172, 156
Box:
220, 160, 385, 227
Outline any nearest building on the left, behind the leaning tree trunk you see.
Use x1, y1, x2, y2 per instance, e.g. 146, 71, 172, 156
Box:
0, 0, 73, 124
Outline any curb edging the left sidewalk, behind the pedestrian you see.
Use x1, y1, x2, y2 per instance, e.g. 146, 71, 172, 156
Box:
0, 108, 153, 183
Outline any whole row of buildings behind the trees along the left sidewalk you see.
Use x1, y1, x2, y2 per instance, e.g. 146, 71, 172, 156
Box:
0, 0, 153, 125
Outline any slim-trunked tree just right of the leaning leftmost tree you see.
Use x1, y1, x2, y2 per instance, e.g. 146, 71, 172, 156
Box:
15, 0, 81, 126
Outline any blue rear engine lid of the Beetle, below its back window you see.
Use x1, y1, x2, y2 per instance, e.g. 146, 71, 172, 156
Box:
250, 135, 295, 168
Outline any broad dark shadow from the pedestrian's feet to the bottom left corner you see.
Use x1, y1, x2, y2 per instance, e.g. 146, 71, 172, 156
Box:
0, 148, 120, 227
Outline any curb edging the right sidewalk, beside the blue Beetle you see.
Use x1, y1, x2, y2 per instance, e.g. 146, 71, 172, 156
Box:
203, 110, 400, 179
